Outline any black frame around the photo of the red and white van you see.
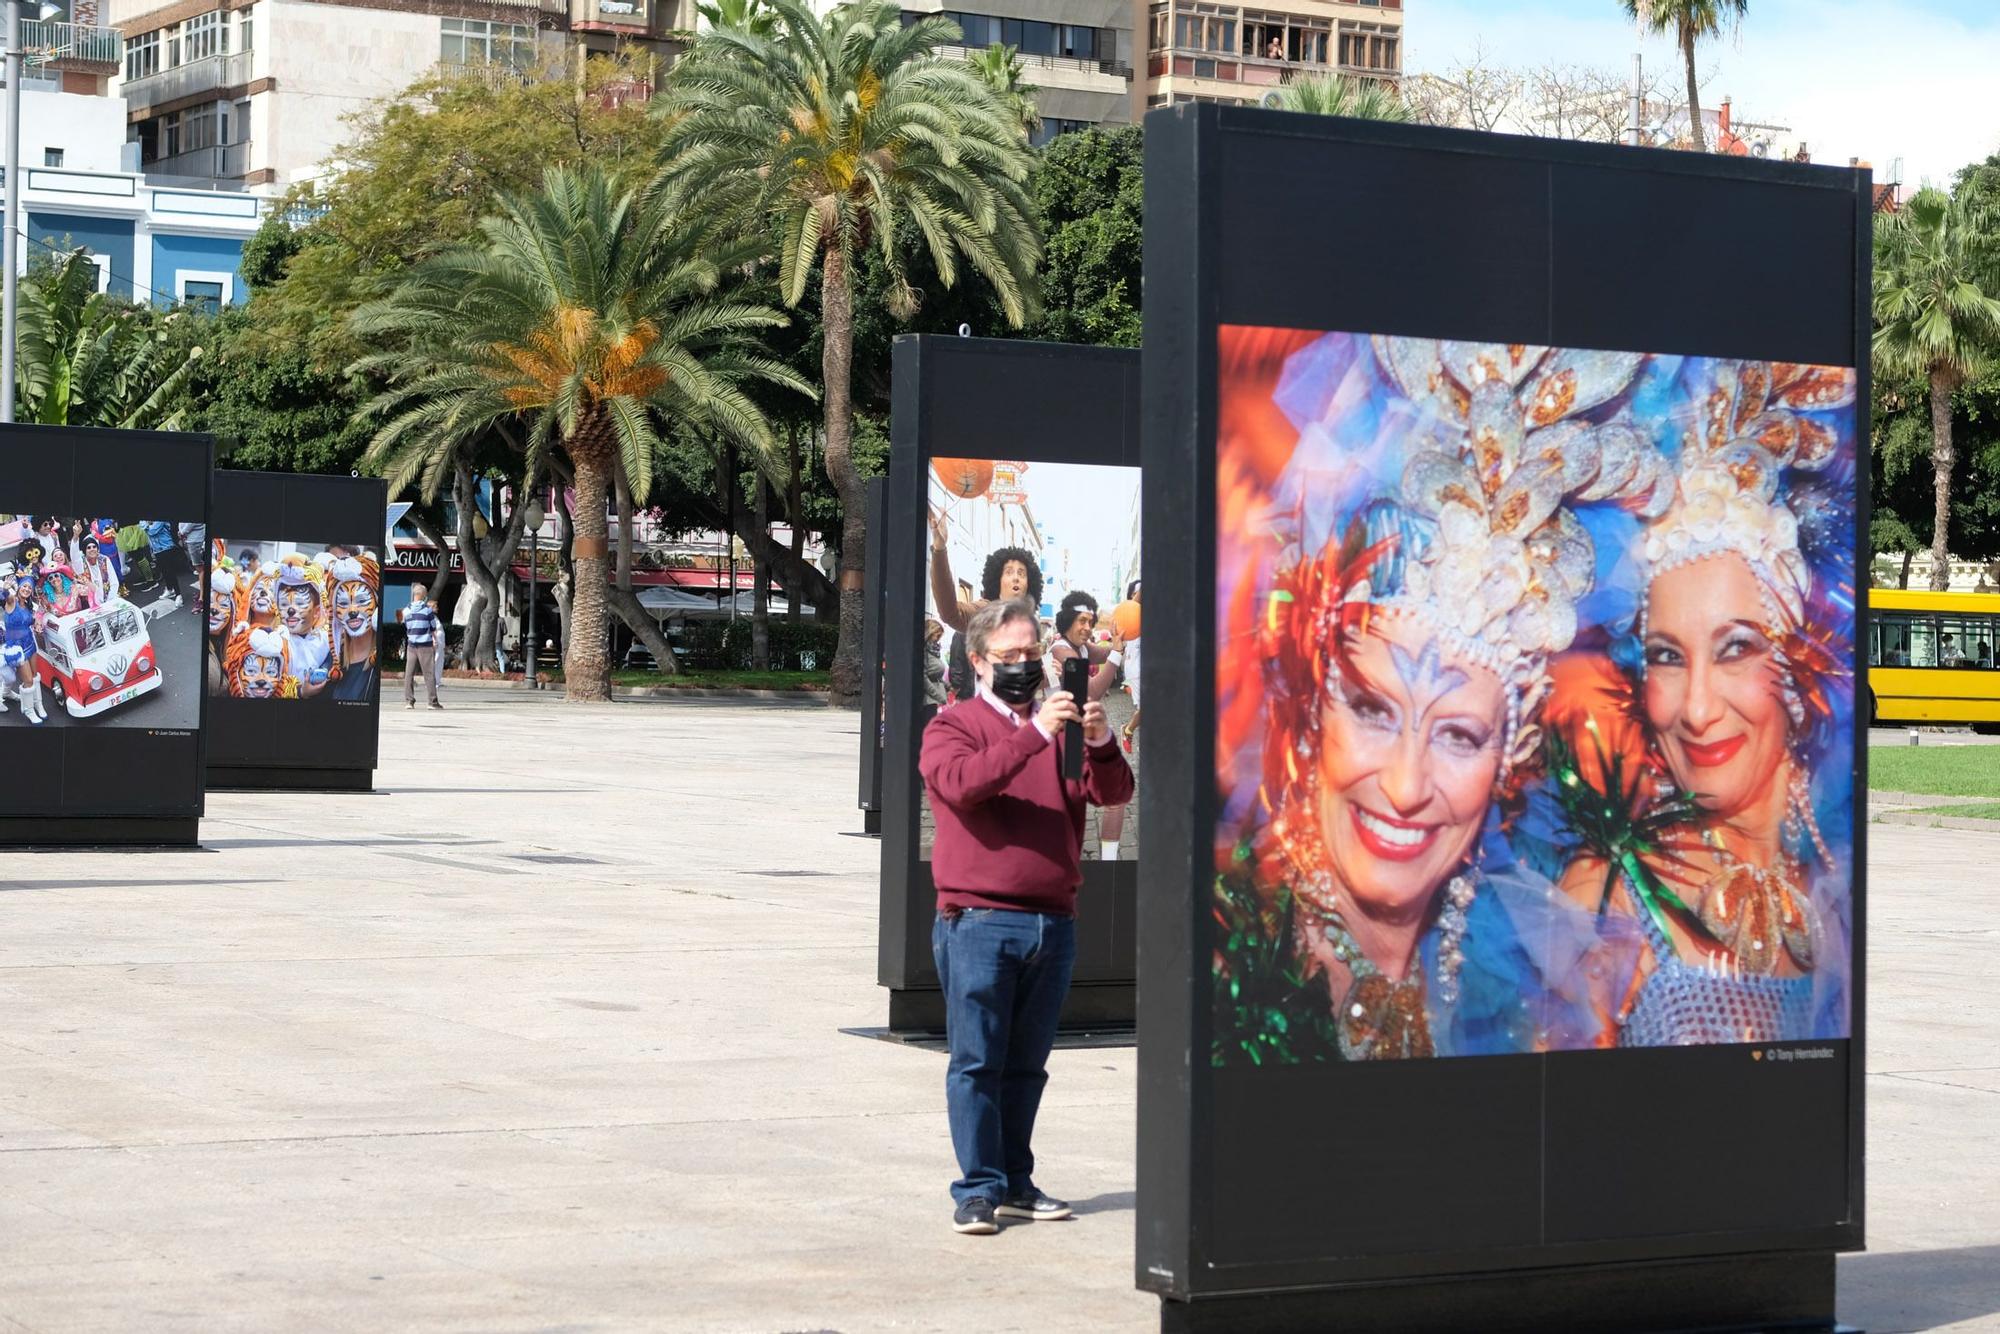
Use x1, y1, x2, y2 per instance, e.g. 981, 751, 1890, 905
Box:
0, 424, 214, 848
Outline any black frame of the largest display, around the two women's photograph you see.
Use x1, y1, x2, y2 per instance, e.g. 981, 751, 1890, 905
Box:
1134, 106, 1872, 1330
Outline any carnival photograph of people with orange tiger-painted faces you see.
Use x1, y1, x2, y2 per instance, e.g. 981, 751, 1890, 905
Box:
208, 538, 382, 704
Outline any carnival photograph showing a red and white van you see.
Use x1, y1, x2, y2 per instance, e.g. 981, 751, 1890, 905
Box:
0, 514, 204, 730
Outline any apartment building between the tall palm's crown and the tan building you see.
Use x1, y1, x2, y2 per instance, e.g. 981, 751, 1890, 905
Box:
902, 0, 1138, 144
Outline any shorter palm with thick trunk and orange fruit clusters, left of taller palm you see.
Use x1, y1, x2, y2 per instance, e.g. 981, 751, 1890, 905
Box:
354, 168, 810, 700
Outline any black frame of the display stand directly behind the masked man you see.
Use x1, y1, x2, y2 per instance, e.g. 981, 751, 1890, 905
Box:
880, 334, 1146, 1032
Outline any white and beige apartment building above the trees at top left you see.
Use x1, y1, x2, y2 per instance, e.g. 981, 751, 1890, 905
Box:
108, 0, 694, 188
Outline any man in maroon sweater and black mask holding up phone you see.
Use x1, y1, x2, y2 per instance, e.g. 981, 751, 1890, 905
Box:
918, 602, 1132, 1232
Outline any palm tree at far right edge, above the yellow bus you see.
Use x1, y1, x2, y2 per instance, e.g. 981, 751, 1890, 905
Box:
1874, 186, 2000, 592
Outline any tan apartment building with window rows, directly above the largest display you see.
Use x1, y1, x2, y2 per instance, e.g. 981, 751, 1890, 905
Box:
1136, 0, 1402, 108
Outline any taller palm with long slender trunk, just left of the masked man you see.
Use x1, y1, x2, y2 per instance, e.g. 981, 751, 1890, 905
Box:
654, 0, 1042, 704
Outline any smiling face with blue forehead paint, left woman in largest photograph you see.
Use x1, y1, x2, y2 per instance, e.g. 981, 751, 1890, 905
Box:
1318, 618, 1506, 916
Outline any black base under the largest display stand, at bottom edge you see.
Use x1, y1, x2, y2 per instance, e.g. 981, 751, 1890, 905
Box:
1160, 1252, 1860, 1334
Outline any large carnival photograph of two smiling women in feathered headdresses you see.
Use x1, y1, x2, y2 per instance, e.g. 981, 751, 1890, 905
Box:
1210, 326, 1856, 1066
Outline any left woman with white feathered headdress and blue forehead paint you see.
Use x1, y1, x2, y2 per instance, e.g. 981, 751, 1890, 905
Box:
1212, 334, 1664, 1064
